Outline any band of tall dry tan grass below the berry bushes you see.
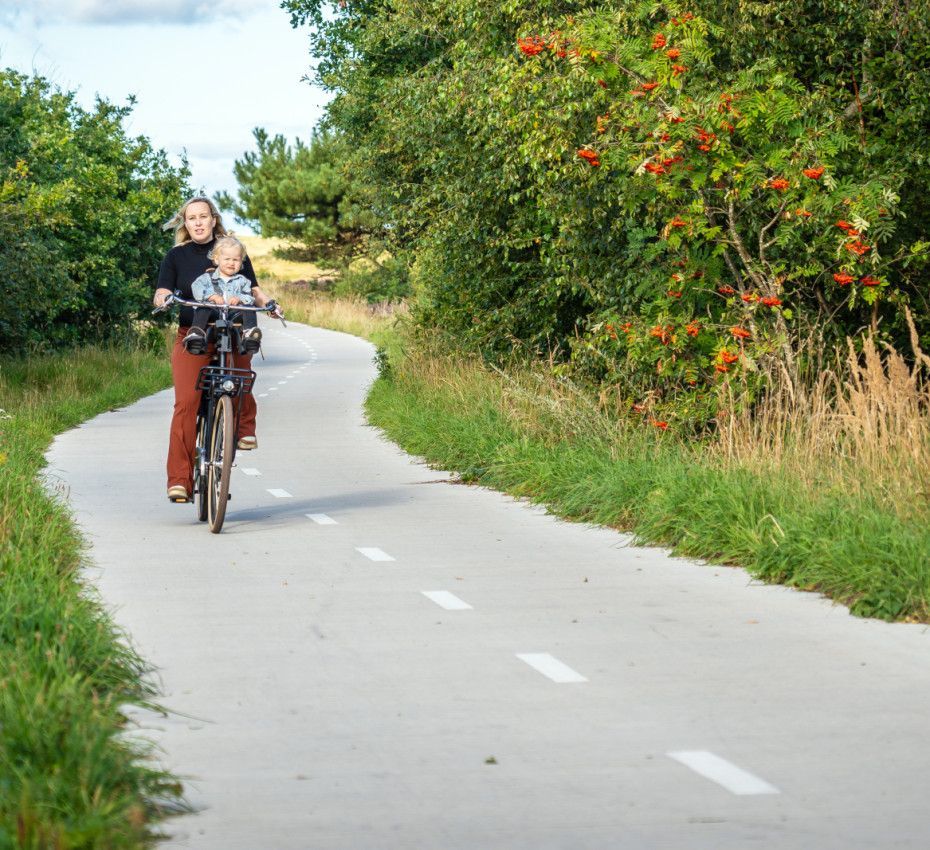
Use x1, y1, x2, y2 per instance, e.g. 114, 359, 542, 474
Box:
390, 314, 930, 519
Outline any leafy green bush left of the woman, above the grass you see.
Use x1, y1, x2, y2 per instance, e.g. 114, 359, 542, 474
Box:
0, 70, 188, 352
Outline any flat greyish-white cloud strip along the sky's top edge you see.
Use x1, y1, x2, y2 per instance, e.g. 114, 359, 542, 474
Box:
0, 0, 268, 27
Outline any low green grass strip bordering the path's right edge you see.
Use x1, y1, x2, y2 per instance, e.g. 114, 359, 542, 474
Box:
367, 346, 930, 622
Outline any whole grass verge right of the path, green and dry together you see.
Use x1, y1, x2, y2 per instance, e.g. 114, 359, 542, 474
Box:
367, 330, 930, 622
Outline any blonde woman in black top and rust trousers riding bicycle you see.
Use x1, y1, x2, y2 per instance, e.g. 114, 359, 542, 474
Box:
153, 196, 280, 502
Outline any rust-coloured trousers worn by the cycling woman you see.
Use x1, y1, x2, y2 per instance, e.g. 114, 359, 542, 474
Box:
168, 328, 257, 493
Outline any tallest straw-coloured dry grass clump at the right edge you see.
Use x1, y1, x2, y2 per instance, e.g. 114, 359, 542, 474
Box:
709, 314, 930, 514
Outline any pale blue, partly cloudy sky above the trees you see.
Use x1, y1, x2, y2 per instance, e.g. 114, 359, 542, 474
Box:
0, 0, 327, 230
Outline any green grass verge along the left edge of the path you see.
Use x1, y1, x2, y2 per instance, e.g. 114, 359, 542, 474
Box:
0, 342, 180, 850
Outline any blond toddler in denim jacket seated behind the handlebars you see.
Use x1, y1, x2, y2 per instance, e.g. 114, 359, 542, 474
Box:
183, 236, 262, 354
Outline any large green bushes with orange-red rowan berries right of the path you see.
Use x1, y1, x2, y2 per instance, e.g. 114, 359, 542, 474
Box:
270, 0, 930, 380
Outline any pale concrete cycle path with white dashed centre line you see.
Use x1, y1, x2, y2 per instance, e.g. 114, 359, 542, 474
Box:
49, 324, 930, 850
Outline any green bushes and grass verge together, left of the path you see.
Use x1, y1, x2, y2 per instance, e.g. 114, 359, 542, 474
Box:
0, 64, 189, 850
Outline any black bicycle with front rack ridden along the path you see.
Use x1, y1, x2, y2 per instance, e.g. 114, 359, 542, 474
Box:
152, 294, 287, 534
